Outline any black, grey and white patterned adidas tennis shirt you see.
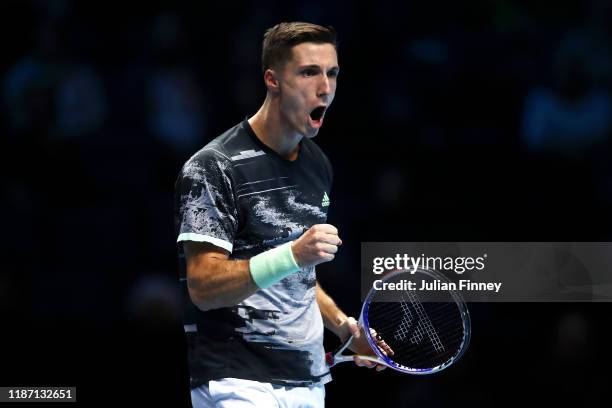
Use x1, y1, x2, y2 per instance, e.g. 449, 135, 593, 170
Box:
175, 119, 332, 388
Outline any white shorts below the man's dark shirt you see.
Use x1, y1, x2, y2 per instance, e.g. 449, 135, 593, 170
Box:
191, 378, 325, 408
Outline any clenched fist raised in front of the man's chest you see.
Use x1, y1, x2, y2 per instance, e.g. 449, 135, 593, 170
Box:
291, 224, 342, 268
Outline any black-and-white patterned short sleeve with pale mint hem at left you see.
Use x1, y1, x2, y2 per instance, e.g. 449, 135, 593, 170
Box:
176, 149, 238, 252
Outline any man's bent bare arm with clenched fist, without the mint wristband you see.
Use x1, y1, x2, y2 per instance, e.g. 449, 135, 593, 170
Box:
183, 224, 342, 311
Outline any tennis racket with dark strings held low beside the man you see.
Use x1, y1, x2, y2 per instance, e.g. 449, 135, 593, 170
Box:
325, 269, 471, 375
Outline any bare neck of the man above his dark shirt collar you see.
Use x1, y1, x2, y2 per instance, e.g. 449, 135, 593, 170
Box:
249, 96, 303, 161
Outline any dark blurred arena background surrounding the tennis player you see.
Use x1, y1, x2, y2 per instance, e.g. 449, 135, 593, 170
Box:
0, 0, 612, 407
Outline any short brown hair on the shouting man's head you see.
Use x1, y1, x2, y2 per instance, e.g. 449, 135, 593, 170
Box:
261, 22, 337, 72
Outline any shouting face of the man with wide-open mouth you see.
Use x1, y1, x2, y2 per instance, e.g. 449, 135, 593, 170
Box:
279, 43, 340, 137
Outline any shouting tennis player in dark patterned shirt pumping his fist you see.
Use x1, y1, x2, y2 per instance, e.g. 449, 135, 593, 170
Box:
176, 22, 386, 407
